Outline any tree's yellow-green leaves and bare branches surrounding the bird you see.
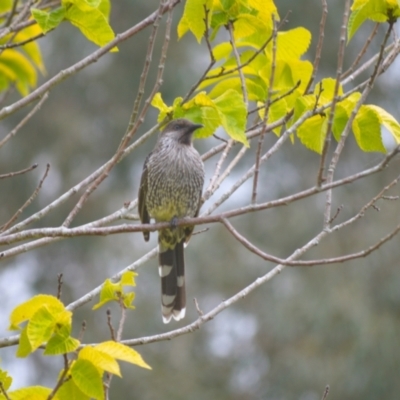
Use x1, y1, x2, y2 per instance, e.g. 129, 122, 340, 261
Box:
0, 0, 400, 400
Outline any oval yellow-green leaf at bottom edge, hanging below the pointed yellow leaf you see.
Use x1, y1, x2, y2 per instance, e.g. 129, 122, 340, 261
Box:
70, 359, 104, 400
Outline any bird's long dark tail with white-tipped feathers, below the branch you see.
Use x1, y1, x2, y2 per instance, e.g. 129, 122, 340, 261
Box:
158, 233, 186, 324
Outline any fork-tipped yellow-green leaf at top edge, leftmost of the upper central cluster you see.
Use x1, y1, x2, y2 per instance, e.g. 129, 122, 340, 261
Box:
178, 0, 210, 43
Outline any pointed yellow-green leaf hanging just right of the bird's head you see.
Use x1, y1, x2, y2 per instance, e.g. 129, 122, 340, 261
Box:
214, 89, 249, 146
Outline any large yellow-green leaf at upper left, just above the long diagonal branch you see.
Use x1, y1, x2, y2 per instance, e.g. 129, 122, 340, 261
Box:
65, 4, 118, 52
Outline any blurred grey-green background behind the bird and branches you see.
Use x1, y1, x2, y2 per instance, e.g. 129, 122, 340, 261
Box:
0, 0, 400, 400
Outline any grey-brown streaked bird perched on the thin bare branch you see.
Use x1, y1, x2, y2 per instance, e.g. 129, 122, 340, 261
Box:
138, 119, 204, 323
